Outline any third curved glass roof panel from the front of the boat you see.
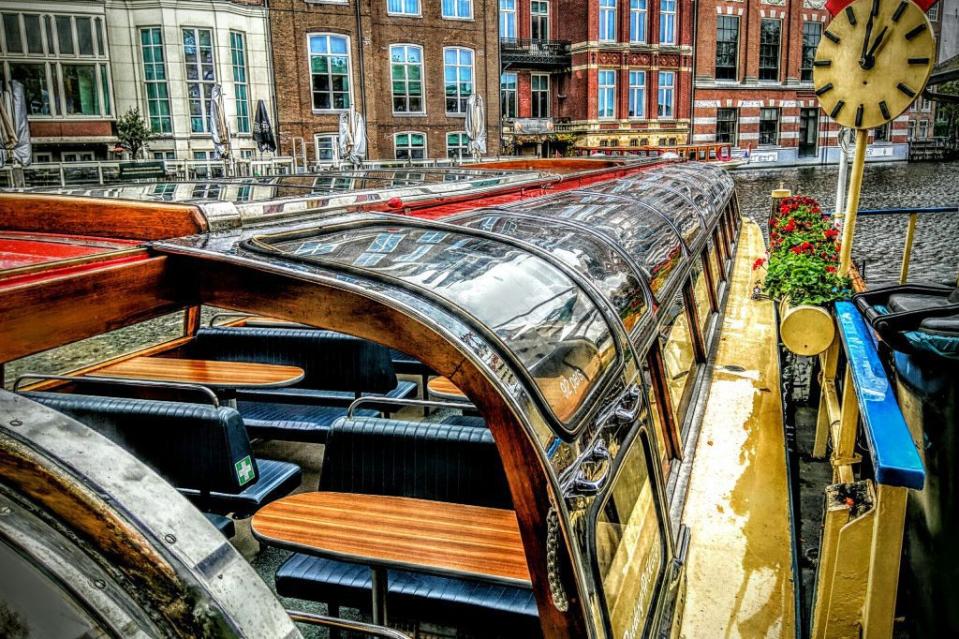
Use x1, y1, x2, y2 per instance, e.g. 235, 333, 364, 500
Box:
507, 191, 684, 295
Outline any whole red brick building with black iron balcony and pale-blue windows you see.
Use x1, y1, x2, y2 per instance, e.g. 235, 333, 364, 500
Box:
500, 0, 694, 153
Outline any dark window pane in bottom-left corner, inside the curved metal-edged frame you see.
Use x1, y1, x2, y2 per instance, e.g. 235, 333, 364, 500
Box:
0, 541, 110, 639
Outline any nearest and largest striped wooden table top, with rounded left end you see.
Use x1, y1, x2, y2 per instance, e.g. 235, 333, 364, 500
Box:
251, 492, 530, 587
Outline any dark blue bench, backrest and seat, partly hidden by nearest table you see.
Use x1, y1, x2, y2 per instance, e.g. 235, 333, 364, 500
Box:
276, 416, 539, 637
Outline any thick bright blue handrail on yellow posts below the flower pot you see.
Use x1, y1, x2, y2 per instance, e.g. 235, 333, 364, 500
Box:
836, 302, 926, 490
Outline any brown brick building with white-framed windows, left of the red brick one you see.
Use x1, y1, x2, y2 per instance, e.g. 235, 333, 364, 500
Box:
270, 0, 500, 163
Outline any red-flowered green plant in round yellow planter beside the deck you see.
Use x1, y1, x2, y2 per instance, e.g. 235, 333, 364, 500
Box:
753, 196, 851, 355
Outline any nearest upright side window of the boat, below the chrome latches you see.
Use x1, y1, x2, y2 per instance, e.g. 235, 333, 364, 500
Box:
595, 432, 666, 637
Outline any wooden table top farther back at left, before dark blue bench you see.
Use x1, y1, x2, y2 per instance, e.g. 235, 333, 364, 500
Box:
87, 357, 303, 388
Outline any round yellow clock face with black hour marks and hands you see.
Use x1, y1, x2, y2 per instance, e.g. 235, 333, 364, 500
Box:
813, 0, 936, 129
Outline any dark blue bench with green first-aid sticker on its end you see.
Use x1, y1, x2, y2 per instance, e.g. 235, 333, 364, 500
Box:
25, 393, 302, 517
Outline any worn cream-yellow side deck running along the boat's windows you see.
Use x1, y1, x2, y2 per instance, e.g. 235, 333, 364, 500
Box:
682, 222, 795, 639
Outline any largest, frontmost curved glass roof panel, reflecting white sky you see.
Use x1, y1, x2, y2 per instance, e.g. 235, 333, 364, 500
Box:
255, 223, 617, 424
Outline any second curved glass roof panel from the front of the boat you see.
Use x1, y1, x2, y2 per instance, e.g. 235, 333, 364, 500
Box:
456, 212, 648, 332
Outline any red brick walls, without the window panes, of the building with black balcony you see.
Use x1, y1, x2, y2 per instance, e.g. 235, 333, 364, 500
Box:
501, 0, 694, 148
